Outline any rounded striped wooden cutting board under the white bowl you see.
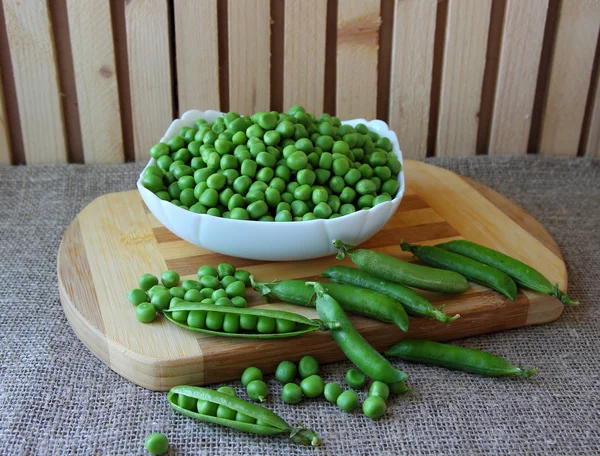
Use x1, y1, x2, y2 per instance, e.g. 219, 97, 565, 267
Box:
58, 160, 567, 390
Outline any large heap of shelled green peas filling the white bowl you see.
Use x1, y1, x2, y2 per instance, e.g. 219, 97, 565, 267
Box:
142, 105, 402, 222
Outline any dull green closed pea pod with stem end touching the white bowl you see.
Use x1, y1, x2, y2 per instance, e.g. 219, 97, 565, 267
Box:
333, 239, 469, 293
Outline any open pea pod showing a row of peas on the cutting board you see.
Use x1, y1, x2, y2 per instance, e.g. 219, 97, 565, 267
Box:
163, 302, 325, 339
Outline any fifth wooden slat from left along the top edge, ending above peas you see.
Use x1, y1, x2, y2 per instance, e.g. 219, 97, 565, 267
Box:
227, 0, 271, 115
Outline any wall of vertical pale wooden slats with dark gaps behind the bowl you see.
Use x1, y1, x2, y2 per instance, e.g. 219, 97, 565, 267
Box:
0, 0, 600, 165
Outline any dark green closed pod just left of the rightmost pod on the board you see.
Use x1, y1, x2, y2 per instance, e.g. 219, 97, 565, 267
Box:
400, 242, 517, 301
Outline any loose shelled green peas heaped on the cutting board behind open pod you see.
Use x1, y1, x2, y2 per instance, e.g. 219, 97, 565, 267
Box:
127, 263, 250, 327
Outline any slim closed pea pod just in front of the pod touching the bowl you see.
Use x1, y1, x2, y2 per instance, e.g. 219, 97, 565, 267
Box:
321, 266, 460, 323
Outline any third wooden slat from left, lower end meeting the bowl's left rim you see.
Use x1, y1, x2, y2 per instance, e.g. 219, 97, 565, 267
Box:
125, 0, 173, 160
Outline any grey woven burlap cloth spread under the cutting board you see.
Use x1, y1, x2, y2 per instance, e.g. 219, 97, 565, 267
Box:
0, 156, 600, 456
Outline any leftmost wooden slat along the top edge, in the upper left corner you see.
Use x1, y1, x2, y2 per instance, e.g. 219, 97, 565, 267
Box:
3, 0, 67, 164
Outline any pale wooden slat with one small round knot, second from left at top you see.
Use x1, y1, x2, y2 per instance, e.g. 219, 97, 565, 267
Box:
67, 0, 125, 163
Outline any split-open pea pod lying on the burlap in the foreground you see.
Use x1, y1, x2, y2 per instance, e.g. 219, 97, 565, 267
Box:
167, 385, 321, 446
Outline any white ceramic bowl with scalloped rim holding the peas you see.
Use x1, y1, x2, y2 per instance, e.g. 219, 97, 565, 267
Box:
137, 110, 405, 261
